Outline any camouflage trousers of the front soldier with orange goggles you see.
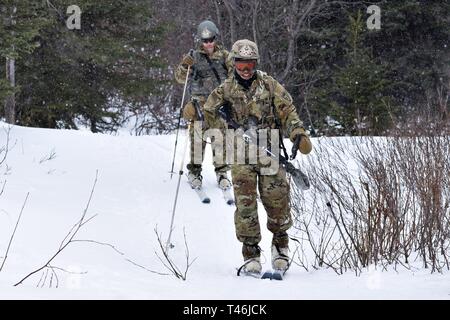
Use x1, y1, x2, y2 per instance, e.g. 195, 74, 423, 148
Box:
231, 165, 292, 260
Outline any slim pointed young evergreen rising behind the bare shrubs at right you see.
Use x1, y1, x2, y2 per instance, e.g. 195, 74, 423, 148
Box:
332, 11, 392, 135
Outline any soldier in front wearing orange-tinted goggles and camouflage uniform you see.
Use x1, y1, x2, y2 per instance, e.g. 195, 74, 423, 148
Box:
204, 40, 312, 273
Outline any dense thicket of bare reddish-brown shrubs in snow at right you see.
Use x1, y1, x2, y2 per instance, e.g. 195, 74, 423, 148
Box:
292, 119, 450, 274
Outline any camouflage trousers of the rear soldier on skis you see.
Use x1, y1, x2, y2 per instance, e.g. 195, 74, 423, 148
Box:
186, 99, 230, 174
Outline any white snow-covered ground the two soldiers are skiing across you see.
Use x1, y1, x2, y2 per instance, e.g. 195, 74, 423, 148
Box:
0, 123, 450, 299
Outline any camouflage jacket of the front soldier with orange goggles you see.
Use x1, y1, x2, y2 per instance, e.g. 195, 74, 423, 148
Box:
204, 70, 303, 140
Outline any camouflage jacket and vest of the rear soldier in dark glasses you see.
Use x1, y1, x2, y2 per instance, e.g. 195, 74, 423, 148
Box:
175, 45, 233, 99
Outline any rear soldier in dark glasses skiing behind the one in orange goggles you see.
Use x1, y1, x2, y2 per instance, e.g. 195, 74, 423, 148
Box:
175, 20, 233, 189
